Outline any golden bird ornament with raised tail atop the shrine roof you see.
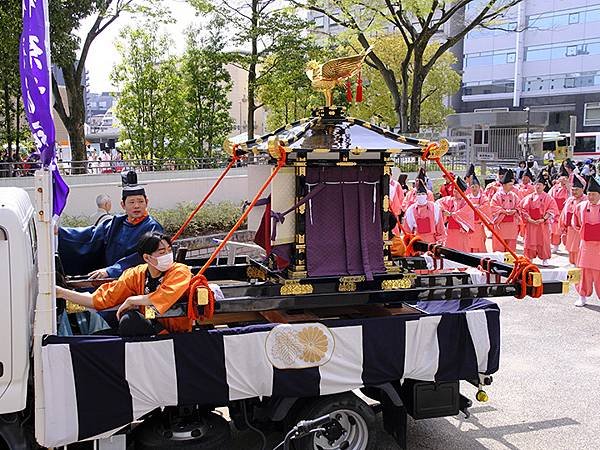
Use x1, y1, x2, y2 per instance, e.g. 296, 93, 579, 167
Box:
306, 47, 371, 106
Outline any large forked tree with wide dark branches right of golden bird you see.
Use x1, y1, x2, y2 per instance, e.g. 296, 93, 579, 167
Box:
298, 0, 522, 133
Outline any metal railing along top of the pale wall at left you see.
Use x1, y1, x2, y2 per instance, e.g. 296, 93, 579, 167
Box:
0, 158, 239, 177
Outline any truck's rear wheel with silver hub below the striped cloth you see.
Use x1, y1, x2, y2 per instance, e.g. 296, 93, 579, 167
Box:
292, 392, 377, 450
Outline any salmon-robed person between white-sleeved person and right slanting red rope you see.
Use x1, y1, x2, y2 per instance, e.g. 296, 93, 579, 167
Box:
437, 178, 475, 252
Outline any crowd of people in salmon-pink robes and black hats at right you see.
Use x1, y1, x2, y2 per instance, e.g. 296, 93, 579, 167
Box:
390, 158, 600, 306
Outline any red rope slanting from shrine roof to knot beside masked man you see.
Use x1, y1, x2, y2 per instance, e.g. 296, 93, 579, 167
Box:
188, 145, 287, 320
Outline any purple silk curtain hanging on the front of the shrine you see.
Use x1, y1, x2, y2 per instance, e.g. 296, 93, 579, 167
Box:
306, 167, 385, 279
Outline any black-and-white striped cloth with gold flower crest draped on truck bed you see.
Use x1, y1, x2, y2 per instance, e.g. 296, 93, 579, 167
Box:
42, 299, 500, 446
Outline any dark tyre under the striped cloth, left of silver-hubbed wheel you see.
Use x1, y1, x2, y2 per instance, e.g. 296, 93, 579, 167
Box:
135, 413, 231, 450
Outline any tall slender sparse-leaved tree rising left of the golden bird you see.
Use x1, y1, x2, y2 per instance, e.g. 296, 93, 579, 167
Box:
189, 0, 314, 139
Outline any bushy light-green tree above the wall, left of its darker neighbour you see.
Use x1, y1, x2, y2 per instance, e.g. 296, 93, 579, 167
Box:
111, 24, 185, 159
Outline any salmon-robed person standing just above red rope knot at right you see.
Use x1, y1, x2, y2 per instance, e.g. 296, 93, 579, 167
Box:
519, 172, 559, 266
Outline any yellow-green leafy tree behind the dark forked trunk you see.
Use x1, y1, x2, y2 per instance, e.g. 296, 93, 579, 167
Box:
351, 33, 460, 130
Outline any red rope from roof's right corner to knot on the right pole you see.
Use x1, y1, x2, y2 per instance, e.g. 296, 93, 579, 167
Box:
421, 142, 544, 298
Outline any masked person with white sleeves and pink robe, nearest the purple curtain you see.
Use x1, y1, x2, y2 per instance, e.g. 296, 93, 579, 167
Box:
403, 180, 445, 243
